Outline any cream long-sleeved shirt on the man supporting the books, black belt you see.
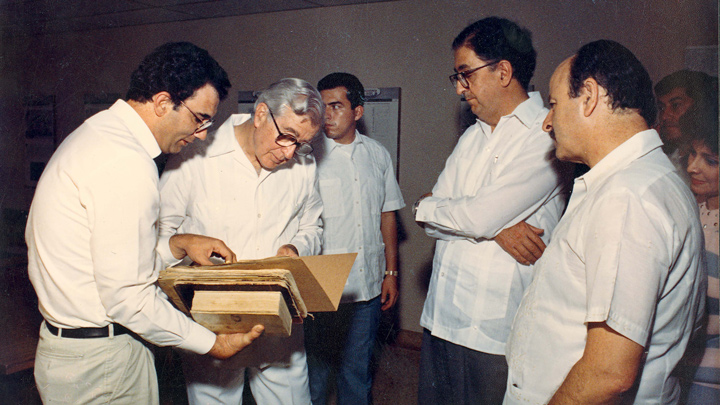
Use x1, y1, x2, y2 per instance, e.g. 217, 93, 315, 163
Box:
25, 100, 215, 354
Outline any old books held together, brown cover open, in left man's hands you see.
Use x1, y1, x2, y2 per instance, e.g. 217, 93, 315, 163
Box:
158, 253, 357, 336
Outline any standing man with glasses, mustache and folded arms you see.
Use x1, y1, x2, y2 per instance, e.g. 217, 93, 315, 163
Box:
415, 17, 565, 404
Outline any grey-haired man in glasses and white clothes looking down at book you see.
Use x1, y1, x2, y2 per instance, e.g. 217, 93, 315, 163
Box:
160, 79, 325, 404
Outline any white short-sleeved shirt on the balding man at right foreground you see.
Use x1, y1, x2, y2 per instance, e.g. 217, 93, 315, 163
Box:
505, 130, 706, 404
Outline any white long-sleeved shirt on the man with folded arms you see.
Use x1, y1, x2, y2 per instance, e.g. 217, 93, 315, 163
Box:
415, 92, 565, 354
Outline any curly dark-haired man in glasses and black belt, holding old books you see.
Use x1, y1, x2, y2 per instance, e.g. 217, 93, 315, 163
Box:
25, 42, 263, 404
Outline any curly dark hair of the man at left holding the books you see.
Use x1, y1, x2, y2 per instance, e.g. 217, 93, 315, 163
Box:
125, 42, 231, 105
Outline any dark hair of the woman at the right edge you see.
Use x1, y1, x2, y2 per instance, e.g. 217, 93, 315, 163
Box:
679, 83, 718, 155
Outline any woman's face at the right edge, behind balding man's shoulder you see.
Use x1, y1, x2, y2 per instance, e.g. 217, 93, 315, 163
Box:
687, 141, 718, 204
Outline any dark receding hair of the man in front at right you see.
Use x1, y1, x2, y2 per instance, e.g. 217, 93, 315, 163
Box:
569, 39, 657, 126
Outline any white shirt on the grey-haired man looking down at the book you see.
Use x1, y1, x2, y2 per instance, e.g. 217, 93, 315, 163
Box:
160, 114, 322, 260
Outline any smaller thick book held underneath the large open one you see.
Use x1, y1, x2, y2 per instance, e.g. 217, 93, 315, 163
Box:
190, 290, 292, 336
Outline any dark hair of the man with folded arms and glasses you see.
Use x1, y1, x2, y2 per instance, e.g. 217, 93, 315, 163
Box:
452, 17, 537, 91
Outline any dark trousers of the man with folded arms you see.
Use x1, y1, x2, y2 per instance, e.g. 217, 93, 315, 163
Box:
418, 329, 508, 405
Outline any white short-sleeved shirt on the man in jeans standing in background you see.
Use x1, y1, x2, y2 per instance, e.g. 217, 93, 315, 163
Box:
315, 131, 405, 303
